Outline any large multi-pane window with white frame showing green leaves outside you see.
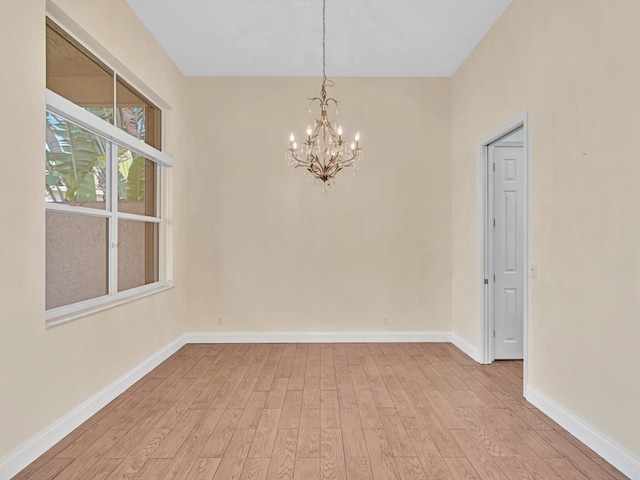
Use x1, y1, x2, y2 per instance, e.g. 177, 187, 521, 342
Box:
44, 19, 171, 324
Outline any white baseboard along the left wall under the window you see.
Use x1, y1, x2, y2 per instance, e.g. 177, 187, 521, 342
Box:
0, 335, 186, 479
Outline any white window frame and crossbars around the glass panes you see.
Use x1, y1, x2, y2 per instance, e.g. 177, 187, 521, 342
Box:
45, 30, 173, 327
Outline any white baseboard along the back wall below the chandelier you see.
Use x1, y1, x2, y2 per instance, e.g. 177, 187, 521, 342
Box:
185, 331, 451, 343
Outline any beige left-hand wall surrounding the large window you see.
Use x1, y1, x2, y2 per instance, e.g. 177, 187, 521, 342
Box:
0, 0, 187, 464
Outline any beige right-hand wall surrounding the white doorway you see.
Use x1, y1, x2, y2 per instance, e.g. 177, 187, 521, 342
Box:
452, 0, 640, 455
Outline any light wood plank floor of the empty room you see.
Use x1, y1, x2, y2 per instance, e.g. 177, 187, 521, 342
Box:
14, 343, 626, 480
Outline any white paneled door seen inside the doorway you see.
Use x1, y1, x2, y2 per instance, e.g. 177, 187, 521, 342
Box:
489, 142, 527, 360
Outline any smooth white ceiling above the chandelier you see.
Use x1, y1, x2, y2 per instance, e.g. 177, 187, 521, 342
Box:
127, 0, 511, 77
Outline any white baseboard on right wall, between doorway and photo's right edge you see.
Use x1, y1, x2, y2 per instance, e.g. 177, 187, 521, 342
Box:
525, 386, 640, 479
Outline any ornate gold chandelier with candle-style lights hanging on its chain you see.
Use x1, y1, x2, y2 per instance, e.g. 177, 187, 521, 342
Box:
287, 0, 362, 193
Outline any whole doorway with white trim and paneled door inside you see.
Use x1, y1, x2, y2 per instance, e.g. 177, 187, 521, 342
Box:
480, 114, 535, 396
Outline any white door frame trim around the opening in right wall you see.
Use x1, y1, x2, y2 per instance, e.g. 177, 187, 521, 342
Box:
478, 112, 531, 396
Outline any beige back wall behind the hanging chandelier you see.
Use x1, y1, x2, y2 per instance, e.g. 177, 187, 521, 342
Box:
187, 78, 451, 332
